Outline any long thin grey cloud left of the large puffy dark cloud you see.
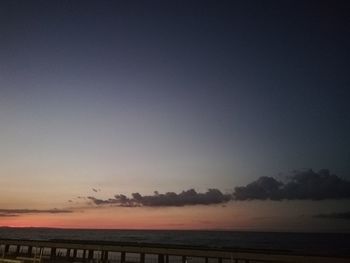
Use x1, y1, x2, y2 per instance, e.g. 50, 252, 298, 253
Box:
88, 189, 232, 207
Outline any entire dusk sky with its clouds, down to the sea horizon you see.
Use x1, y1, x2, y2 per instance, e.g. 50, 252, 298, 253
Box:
0, 0, 350, 232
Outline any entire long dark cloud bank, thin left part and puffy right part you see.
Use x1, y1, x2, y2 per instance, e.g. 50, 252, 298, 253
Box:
88, 169, 350, 207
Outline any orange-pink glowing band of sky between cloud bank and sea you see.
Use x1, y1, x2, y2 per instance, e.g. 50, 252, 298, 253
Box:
0, 201, 346, 231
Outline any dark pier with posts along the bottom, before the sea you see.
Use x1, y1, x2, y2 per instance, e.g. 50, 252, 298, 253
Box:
0, 239, 350, 263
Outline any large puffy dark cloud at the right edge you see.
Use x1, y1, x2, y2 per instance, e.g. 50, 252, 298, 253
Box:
233, 169, 350, 200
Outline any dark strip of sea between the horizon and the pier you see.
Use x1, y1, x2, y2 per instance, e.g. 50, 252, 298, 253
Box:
0, 227, 350, 256
